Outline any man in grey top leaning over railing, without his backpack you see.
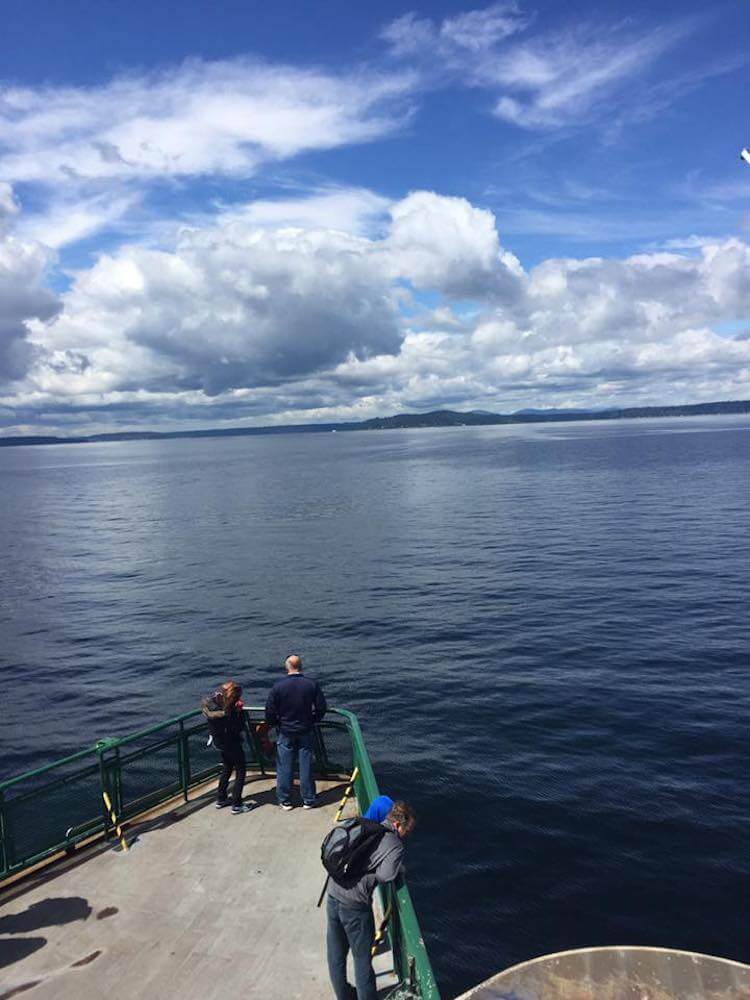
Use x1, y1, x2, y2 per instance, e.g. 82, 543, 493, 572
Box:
326, 802, 416, 1000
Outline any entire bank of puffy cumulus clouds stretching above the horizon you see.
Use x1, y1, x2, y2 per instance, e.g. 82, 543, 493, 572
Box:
0, 191, 750, 434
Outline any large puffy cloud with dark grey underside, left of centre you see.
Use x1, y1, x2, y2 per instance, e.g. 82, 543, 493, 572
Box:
34, 223, 401, 395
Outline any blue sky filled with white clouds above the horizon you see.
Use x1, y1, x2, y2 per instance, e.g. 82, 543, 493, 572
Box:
0, 0, 750, 436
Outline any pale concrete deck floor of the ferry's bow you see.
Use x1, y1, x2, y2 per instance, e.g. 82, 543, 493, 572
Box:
0, 778, 395, 1000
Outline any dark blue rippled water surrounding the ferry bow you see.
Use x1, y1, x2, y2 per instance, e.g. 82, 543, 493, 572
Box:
0, 418, 750, 997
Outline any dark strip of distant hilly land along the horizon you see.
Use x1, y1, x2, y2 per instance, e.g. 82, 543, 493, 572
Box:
0, 400, 750, 447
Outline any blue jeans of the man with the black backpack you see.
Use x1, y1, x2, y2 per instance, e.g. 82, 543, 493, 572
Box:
326, 895, 378, 1000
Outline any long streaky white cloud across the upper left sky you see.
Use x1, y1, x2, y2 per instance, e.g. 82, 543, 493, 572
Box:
0, 60, 412, 184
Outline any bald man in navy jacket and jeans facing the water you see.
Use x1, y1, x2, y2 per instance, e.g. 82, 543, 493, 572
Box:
266, 653, 328, 810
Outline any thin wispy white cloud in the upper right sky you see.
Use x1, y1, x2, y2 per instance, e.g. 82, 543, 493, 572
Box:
381, 2, 696, 136
